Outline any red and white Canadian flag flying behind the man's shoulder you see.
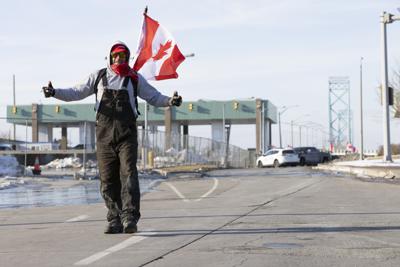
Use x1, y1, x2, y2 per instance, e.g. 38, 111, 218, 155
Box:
133, 13, 185, 80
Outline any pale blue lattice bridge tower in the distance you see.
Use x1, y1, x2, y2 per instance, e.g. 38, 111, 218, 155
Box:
329, 77, 353, 152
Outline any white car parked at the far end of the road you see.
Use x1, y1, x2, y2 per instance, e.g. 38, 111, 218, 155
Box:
256, 148, 299, 168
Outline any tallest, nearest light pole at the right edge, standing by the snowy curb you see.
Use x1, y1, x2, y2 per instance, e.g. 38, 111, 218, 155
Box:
381, 12, 400, 161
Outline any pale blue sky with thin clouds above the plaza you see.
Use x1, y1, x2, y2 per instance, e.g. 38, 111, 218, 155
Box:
0, 0, 400, 152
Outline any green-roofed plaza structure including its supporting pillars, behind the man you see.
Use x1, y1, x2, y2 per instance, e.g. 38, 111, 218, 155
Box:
7, 98, 277, 153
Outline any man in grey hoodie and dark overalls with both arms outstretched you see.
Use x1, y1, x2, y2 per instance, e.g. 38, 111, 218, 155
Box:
43, 42, 182, 234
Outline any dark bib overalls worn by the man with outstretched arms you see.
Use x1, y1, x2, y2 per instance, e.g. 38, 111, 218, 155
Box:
96, 78, 140, 225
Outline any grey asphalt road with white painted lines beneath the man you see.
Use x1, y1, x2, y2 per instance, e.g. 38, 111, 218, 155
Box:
0, 167, 400, 267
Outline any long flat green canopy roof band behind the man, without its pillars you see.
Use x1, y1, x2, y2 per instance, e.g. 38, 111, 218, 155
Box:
7, 99, 277, 126
